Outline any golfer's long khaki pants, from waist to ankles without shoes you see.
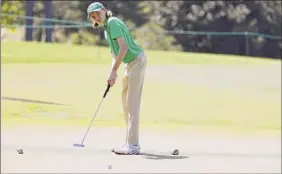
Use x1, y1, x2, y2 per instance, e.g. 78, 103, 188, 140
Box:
122, 52, 147, 145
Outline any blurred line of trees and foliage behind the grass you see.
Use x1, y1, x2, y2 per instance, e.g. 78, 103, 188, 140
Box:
1, 0, 282, 59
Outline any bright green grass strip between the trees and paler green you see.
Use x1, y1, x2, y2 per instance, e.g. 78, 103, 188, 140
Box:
1, 41, 281, 65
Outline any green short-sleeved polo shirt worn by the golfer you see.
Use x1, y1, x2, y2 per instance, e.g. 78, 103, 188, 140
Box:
105, 17, 142, 63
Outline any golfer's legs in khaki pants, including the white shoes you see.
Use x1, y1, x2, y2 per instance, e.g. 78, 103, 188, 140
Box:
114, 51, 147, 154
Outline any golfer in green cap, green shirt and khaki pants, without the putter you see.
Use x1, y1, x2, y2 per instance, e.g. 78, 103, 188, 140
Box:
87, 2, 147, 155
